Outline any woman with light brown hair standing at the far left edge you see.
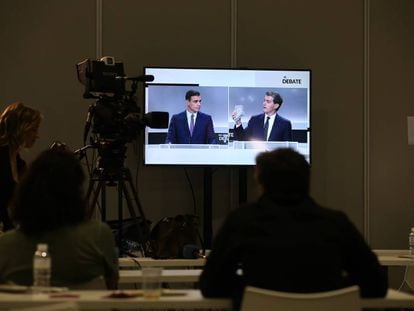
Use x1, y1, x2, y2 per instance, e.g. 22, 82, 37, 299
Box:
0, 102, 42, 231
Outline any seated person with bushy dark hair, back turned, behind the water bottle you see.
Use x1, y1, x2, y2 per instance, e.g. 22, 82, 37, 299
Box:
0, 148, 118, 289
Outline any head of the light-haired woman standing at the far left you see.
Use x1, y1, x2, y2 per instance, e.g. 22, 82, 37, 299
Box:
0, 102, 42, 150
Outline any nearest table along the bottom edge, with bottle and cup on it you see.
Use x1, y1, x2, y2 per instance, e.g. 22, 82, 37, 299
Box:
0, 289, 414, 311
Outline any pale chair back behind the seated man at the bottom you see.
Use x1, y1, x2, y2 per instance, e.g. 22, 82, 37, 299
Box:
240, 286, 361, 311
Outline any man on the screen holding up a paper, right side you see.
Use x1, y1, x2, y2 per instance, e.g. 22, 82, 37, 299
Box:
232, 92, 292, 141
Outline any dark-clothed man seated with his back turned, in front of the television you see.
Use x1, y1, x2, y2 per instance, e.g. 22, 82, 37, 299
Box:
199, 148, 388, 310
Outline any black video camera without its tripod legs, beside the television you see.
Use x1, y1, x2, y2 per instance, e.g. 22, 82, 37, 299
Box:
76, 56, 169, 143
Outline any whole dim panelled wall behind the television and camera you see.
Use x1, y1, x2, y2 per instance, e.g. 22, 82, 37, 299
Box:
0, 0, 414, 288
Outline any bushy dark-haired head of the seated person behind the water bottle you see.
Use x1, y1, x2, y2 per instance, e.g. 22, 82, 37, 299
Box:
12, 148, 86, 234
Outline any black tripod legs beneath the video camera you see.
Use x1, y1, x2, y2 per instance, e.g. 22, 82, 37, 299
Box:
87, 162, 150, 256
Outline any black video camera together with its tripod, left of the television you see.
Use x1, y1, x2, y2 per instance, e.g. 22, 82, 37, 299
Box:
75, 56, 165, 254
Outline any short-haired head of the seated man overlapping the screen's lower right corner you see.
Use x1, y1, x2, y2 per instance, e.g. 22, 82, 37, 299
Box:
256, 148, 310, 204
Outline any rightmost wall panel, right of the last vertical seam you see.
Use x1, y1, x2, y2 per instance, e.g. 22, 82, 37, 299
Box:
367, 1, 414, 248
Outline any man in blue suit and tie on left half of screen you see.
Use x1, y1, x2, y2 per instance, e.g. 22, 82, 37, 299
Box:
166, 90, 217, 144
